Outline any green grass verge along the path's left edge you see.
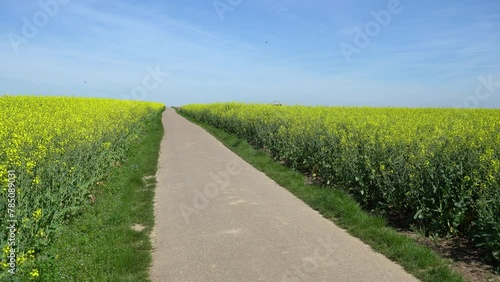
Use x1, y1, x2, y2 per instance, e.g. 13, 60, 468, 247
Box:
40, 110, 163, 281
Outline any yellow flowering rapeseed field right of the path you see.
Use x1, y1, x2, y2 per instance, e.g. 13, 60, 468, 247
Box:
181, 103, 500, 260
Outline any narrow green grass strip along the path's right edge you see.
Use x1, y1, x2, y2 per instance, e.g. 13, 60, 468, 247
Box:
179, 109, 464, 282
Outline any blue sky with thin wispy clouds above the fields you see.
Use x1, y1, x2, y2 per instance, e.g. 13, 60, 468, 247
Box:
0, 0, 500, 108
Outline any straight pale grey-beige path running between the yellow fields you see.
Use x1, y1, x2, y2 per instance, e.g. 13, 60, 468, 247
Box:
151, 109, 417, 282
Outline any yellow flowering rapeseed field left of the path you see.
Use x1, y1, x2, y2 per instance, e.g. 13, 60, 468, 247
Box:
0, 96, 164, 280
